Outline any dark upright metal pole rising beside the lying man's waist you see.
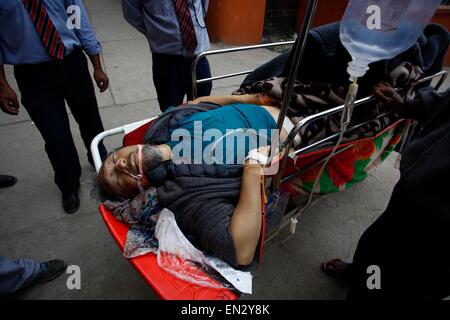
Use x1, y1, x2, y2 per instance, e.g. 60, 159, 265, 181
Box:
269, 0, 317, 188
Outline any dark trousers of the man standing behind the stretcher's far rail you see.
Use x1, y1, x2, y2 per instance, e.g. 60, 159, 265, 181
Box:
152, 53, 212, 111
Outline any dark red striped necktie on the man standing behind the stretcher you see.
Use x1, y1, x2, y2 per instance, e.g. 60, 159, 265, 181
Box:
174, 0, 198, 54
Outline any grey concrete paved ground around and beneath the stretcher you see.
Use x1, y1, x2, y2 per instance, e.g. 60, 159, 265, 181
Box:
0, 0, 448, 300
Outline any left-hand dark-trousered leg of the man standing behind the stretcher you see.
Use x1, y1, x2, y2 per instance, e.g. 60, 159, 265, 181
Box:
152, 53, 186, 111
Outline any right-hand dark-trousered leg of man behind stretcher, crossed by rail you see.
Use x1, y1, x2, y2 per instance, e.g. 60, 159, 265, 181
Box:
185, 57, 212, 100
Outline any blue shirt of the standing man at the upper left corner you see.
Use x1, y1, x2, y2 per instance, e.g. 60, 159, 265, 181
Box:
0, 0, 101, 65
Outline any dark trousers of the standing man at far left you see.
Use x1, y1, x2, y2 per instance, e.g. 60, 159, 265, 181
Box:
14, 50, 106, 192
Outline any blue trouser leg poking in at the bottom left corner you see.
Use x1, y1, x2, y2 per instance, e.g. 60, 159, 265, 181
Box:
0, 256, 39, 295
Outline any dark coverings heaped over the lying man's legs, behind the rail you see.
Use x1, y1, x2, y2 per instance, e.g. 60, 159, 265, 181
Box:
233, 23, 449, 146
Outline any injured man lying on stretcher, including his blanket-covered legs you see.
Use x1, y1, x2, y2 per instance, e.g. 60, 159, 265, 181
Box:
99, 23, 448, 267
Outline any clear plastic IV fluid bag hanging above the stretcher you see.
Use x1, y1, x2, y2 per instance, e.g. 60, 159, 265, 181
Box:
340, 0, 442, 78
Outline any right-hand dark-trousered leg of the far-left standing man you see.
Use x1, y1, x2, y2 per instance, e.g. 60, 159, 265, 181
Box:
62, 51, 107, 165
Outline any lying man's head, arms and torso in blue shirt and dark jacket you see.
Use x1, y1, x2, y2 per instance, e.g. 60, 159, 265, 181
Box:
99, 94, 293, 267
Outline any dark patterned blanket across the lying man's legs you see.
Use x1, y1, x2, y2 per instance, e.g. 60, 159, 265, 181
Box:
235, 62, 423, 146
